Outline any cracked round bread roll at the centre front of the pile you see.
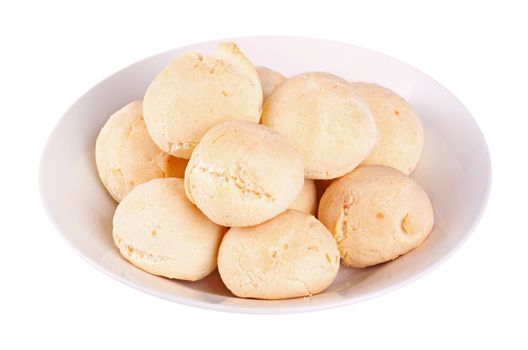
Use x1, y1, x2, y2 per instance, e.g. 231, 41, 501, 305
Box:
185, 120, 304, 226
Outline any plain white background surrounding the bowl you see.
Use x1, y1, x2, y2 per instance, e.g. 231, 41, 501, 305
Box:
0, 0, 528, 349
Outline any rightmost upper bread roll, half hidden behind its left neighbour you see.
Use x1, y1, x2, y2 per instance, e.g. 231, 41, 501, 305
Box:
351, 82, 423, 175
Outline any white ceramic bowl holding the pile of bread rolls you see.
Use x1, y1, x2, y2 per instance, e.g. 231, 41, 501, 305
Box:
40, 37, 491, 313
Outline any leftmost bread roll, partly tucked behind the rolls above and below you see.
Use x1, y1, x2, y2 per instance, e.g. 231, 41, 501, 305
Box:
95, 101, 187, 202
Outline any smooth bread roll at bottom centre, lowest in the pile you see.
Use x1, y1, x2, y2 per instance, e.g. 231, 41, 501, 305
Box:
218, 210, 339, 299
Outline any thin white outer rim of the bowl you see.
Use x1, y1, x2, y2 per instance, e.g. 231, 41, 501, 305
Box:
38, 35, 493, 314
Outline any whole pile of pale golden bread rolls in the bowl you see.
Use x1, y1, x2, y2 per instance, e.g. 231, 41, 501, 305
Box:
96, 43, 433, 299
